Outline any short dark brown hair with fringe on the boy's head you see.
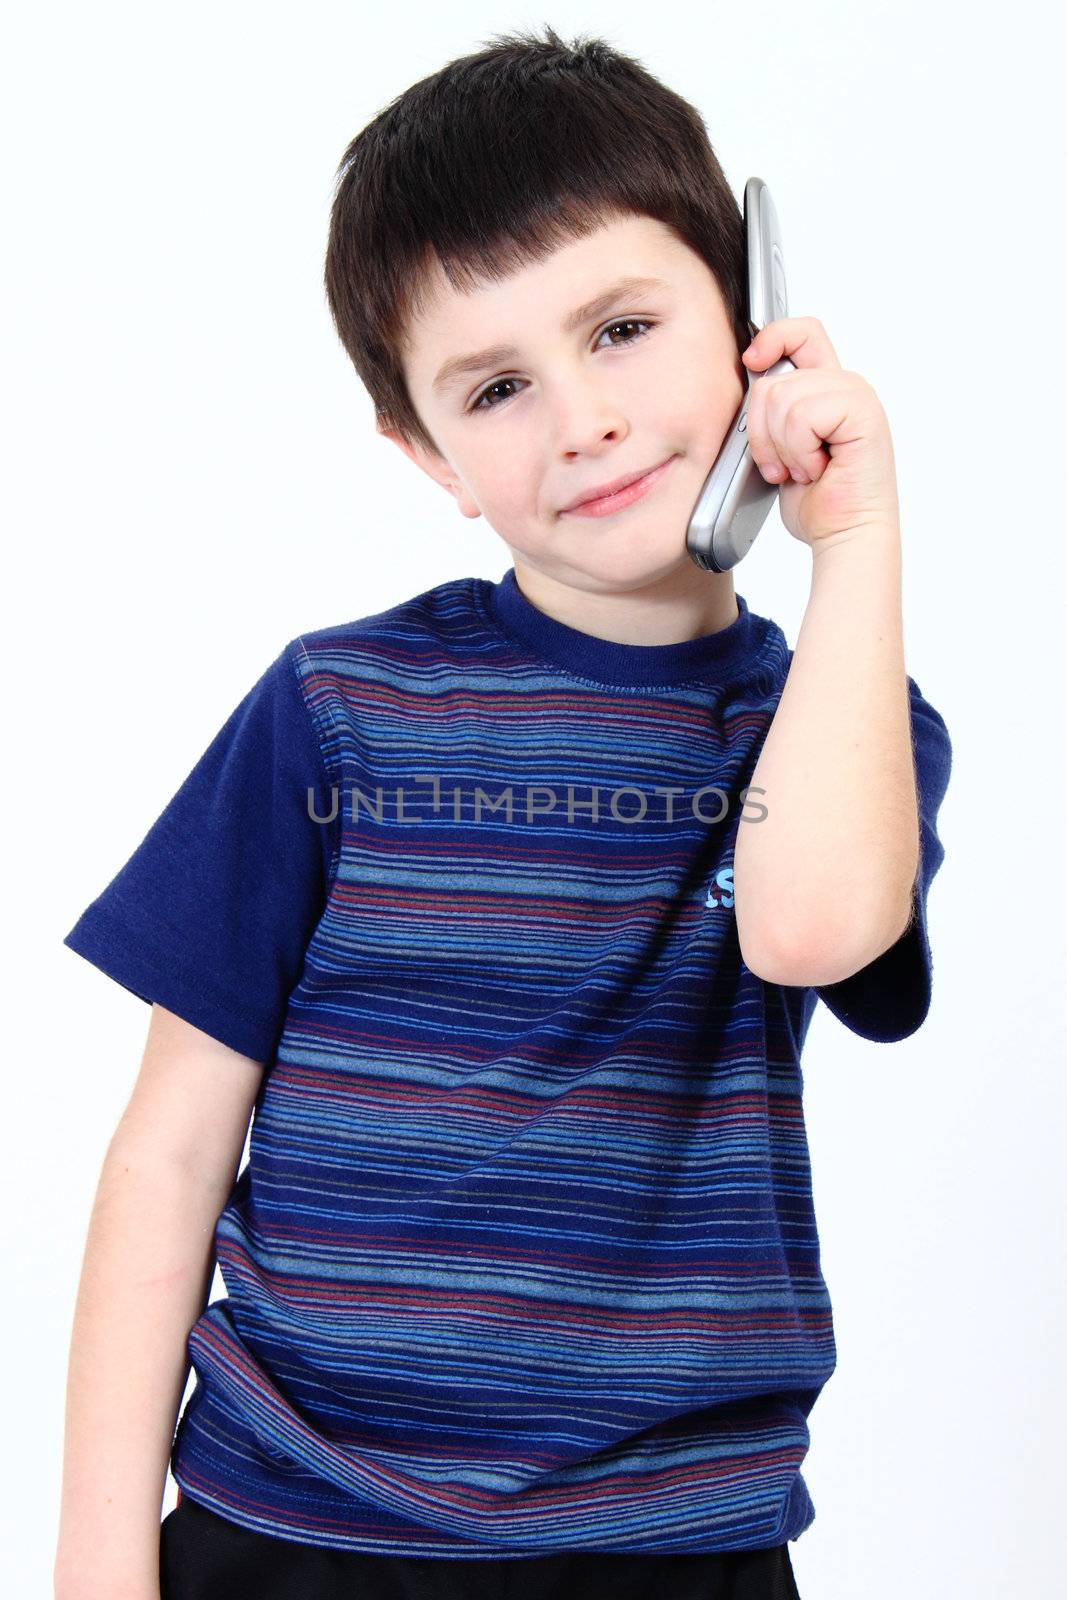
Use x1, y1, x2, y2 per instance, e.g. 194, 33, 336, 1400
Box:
325, 24, 752, 454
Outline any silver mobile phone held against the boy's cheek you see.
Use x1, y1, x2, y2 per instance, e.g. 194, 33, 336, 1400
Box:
686, 178, 797, 573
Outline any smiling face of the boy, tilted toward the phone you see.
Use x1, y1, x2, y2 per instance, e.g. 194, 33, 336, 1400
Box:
387, 216, 745, 616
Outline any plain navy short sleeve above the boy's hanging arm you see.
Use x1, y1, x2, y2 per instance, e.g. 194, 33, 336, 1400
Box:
62, 640, 338, 1062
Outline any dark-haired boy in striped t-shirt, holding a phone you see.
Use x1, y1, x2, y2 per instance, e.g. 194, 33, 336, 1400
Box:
56, 29, 950, 1600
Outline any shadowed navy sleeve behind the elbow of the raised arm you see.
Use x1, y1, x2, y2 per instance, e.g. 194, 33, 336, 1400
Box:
814, 678, 952, 1043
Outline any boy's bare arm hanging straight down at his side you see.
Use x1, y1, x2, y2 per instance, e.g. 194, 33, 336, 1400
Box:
53, 1005, 264, 1600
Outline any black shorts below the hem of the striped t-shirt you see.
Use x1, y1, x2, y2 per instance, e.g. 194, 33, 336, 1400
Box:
160, 1494, 800, 1600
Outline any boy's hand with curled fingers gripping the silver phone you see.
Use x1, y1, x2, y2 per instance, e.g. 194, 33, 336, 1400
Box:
742, 317, 899, 554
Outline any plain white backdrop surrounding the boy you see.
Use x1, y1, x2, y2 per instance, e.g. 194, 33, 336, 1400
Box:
0, 0, 1067, 1600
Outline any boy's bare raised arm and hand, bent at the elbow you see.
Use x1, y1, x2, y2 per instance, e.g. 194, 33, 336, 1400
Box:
734, 317, 920, 986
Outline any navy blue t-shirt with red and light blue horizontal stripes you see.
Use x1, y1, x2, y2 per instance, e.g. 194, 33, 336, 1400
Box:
64, 570, 950, 1557
